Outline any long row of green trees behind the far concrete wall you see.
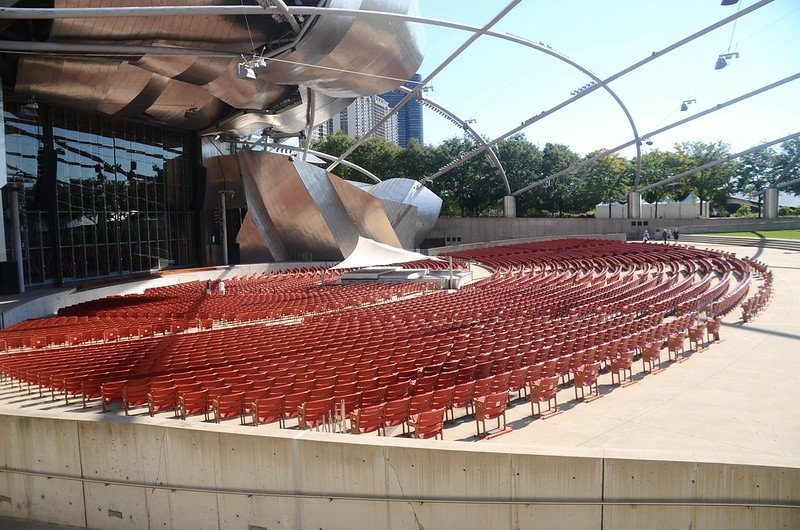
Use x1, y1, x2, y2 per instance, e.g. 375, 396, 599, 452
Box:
312, 133, 800, 217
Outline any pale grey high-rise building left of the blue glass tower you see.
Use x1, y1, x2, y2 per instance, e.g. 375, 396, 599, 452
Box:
311, 96, 398, 143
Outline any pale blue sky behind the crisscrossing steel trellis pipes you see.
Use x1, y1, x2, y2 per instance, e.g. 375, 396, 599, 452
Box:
412, 0, 800, 156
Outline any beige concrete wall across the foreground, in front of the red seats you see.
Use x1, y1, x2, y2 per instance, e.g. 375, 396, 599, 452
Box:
0, 414, 800, 530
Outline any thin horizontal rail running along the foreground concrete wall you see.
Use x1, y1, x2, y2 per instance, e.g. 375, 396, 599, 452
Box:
0, 467, 800, 510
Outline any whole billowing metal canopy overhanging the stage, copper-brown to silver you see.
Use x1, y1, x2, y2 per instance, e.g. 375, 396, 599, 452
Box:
9, 0, 423, 136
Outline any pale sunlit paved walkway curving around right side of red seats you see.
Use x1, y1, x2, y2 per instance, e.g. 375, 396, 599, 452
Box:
446, 240, 800, 467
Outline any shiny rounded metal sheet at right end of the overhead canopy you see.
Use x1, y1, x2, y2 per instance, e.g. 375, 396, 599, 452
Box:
257, 0, 424, 97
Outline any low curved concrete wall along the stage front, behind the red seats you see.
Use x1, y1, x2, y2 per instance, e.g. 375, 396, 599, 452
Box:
0, 262, 335, 328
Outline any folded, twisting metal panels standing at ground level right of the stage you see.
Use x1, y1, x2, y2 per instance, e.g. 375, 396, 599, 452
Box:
220, 151, 441, 260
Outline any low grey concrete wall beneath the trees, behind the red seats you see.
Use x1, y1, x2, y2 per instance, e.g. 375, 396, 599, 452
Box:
428, 217, 800, 249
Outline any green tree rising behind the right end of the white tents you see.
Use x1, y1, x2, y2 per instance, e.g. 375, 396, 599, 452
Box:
675, 142, 736, 216
